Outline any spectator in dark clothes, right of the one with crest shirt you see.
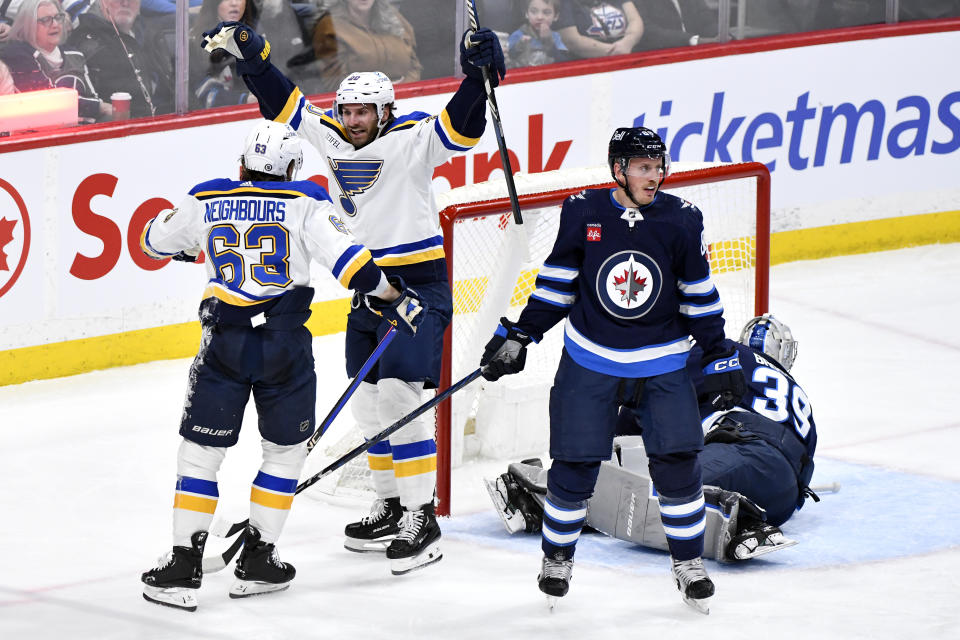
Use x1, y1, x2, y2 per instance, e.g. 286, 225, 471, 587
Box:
634, 0, 719, 51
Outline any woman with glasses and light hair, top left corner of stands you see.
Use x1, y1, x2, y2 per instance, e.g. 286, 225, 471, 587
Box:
0, 0, 113, 122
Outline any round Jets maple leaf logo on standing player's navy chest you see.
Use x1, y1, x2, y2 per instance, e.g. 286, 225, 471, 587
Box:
597, 251, 663, 320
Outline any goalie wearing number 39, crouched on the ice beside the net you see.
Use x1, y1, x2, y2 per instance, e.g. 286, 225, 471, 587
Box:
487, 314, 817, 561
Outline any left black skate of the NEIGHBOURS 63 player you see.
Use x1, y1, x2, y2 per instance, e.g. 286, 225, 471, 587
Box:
140, 531, 207, 611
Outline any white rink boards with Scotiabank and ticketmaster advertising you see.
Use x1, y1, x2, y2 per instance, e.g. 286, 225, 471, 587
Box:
0, 32, 960, 350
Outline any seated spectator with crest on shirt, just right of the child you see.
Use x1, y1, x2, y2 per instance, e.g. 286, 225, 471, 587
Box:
556, 0, 643, 58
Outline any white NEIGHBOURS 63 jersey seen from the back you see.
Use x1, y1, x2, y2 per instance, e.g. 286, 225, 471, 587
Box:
140, 179, 385, 307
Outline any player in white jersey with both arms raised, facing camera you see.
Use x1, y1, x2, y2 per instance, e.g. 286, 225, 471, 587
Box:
203, 18, 505, 574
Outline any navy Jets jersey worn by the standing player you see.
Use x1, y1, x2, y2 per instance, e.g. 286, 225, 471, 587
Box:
517, 189, 723, 378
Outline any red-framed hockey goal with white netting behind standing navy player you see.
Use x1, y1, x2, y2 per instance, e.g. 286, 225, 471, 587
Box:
437, 162, 770, 514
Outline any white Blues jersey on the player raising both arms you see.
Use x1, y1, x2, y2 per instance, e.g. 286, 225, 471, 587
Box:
243, 65, 486, 284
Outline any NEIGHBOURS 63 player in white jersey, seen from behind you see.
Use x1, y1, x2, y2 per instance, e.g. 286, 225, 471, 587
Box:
140, 122, 425, 611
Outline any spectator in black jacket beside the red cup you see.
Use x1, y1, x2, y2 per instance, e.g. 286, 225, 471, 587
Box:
68, 0, 173, 117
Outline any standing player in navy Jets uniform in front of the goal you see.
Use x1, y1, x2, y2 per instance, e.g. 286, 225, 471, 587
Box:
481, 127, 744, 611
